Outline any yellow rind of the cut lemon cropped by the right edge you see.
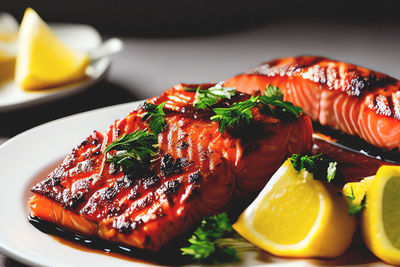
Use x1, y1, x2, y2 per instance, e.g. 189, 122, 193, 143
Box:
361, 166, 400, 265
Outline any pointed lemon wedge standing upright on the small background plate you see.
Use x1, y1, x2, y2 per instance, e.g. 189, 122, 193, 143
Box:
15, 8, 90, 90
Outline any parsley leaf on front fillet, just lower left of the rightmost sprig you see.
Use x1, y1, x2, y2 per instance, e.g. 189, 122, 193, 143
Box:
210, 96, 259, 133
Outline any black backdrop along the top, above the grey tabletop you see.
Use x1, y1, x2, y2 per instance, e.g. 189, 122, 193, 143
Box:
0, 0, 400, 37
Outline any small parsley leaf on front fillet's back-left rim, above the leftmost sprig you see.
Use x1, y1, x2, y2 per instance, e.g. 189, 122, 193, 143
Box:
142, 102, 167, 135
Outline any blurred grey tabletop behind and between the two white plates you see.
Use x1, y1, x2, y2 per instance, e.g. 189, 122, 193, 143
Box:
0, 22, 400, 266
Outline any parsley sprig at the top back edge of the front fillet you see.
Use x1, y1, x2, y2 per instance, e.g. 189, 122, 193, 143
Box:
185, 83, 236, 109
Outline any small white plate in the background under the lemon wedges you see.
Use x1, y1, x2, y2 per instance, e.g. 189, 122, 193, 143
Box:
0, 24, 111, 112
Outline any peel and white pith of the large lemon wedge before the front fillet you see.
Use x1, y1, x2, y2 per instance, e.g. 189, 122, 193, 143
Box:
233, 160, 357, 258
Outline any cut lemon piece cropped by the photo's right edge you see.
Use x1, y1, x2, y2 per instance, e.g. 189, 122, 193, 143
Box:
361, 166, 400, 265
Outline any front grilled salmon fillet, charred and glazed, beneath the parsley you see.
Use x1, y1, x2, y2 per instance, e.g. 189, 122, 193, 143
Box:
30, 84, 312, 250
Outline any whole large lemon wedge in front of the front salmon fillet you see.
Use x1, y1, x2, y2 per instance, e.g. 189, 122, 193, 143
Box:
233, 160, 357, 258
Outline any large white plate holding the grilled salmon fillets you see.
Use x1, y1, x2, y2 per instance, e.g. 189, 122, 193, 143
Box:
0, 102, 386, 267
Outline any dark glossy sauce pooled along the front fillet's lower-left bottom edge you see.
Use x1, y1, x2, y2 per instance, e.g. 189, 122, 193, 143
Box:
28, 215, 190, 266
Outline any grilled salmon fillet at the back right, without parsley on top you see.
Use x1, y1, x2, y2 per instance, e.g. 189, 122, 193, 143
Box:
225, 56, 400, 152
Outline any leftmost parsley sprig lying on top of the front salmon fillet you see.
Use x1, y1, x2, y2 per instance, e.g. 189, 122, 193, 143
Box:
105, 129, 158, 176
